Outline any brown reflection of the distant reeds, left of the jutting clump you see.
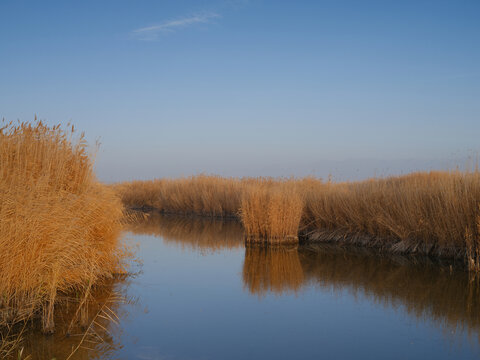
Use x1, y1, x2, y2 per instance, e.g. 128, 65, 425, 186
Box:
128, 212, 244, 251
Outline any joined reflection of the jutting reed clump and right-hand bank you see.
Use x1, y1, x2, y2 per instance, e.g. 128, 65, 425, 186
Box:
243, 245, 480, 336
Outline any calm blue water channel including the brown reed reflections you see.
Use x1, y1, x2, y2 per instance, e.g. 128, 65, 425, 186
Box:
20, 217, 480, 360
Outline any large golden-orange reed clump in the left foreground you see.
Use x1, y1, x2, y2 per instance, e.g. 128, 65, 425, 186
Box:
0, 122, 125, 331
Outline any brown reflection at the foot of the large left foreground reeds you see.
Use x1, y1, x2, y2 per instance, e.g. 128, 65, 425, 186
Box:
7, 278, 131, 360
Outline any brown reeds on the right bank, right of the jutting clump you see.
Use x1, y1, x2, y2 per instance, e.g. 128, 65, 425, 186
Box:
303, 171, 480, 257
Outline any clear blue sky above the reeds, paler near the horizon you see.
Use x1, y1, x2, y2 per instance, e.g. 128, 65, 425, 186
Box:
0, 0, 480, 182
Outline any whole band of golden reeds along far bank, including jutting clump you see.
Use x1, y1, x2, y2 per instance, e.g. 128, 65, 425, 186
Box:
113, 171, 480, 270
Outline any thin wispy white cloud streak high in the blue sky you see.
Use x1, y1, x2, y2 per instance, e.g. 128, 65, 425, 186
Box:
131, 12, 220, 40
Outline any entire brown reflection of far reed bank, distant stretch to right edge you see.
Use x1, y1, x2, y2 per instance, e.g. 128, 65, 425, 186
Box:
129, 213, 480, 340
